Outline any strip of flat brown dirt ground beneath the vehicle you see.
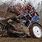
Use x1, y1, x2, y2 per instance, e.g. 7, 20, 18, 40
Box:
0, 37, 42, 42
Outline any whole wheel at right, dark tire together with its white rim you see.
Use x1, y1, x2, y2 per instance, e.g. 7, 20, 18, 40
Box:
29, 23, 42, 38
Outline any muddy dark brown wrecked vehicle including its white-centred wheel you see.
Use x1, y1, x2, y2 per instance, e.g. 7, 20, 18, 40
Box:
0, 14, 42, 38
